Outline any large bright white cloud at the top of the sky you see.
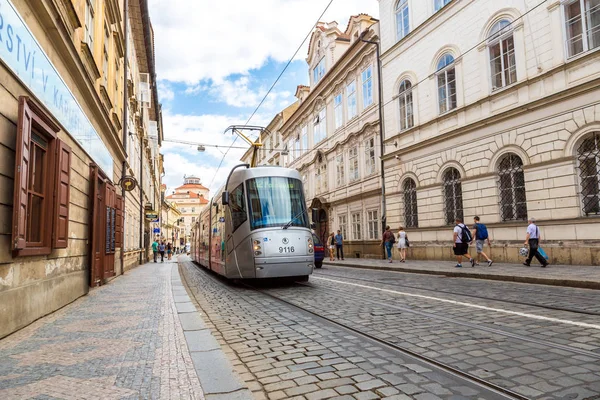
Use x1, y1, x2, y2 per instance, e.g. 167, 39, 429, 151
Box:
150, 0, 379, 85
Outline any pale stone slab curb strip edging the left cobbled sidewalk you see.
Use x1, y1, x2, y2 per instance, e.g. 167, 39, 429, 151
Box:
171, 262, 254, 400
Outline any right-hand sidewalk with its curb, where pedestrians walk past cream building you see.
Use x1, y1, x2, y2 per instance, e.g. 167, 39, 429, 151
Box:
324, 258, 600, 289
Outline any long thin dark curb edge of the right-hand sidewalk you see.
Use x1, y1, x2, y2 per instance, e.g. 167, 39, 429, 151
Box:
323, 261, 600, 290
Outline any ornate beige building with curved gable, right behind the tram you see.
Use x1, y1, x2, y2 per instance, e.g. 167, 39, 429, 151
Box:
280, 14, 382, 257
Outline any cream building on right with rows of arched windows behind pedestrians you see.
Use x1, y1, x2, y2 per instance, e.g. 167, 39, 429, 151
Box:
380, 0, 600, 265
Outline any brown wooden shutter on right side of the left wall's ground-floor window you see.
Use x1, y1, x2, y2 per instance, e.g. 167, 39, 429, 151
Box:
52, 140, 71, 249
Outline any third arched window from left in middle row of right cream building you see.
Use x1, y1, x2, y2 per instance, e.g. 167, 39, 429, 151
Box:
488, 19, 517, 90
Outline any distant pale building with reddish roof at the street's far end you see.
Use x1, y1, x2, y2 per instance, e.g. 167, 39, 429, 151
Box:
166, 176, 210, 245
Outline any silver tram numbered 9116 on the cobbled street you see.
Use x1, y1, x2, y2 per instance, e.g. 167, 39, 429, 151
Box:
191, 164, 314, 281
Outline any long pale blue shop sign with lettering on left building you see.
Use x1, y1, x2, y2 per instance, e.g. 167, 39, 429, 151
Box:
0, 0, 113, 177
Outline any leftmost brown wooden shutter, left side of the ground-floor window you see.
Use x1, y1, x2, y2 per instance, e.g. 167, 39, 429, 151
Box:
12, 97, 32, 250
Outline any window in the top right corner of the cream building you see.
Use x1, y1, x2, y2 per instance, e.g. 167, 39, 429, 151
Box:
564, 0, 600, 57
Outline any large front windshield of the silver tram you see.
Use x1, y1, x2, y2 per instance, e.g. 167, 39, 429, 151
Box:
246, 177, 308, 230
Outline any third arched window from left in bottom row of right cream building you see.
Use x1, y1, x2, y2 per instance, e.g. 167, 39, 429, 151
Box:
498, 153, 527, 221
